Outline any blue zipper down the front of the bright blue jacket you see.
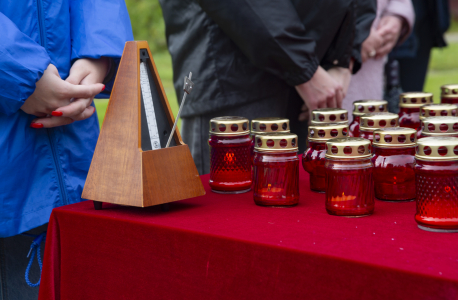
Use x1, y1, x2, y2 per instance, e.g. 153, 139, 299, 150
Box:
37, 0, 68, 205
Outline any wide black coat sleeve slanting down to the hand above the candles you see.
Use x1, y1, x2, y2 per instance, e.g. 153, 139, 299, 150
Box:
198, 0, 319, 86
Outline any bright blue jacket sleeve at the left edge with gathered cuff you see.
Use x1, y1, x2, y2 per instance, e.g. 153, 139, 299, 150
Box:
0, 13, 51, 115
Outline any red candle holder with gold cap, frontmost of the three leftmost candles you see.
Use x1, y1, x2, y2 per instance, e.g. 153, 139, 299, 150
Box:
253, 133, 299, 206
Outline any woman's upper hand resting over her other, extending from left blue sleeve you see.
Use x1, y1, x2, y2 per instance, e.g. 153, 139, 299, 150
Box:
21, 64, 103, 127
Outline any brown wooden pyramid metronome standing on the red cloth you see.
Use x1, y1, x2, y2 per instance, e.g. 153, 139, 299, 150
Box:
82, 41, 205, 209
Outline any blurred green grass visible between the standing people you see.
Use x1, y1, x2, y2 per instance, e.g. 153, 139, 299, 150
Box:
95, 0, 458, 128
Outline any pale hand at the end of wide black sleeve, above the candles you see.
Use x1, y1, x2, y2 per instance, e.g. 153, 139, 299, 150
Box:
296, 67, 343, 121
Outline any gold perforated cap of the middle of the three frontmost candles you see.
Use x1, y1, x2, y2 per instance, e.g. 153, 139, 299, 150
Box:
326, 137, 372, 158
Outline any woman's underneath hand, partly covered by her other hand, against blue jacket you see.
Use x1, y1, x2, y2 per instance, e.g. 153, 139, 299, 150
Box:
33, 58, 109, 127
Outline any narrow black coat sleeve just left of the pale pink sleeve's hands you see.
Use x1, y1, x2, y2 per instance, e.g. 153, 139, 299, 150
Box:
352, 0, 377, 73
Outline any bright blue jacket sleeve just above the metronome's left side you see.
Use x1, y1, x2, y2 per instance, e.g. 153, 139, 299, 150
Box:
70, 0, 134, 91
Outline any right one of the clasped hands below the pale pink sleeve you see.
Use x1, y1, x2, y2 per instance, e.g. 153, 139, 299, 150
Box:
376, 16, 403, 58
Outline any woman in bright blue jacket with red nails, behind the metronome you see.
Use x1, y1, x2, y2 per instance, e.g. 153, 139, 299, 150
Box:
0, 0, 133, 300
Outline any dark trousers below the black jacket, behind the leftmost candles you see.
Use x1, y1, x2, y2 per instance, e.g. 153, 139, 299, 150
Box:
181, 88, 308, 175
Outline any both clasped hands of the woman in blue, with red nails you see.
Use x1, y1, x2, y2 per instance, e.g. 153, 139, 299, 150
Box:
21, 58, 109, 128
